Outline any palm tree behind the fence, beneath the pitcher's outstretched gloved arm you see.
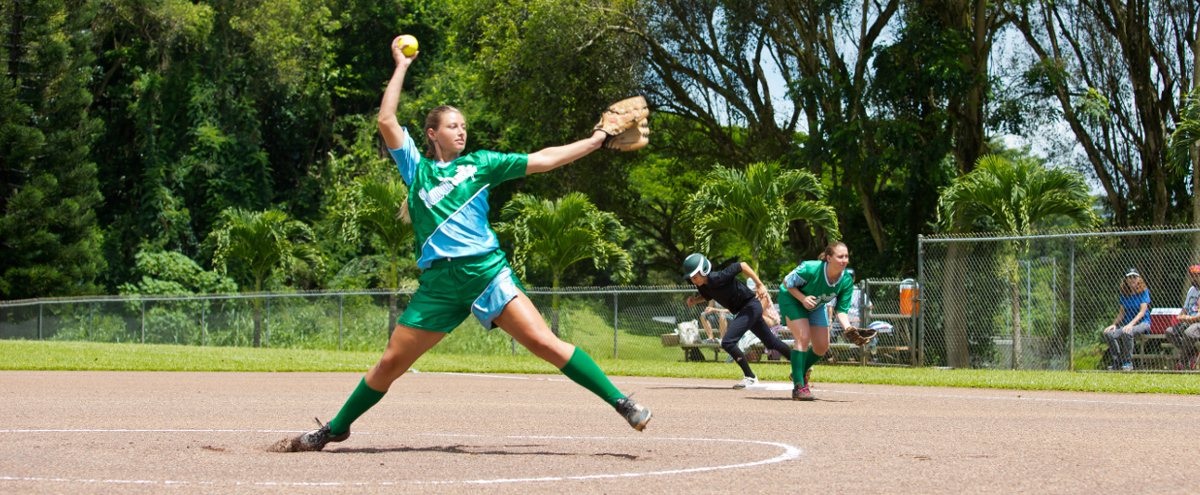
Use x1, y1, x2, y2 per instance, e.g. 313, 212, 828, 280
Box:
496, 192, 632, 335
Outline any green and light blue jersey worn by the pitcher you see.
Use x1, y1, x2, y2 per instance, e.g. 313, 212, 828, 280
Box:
388, 129, 529, 269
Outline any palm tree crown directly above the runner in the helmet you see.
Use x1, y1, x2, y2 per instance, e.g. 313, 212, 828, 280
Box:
688, 162, 838, 270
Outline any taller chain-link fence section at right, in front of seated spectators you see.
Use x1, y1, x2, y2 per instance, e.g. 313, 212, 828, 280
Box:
917, 228, 1200, 370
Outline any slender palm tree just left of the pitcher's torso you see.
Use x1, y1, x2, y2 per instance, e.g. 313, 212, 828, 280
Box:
330, 177, 413, 335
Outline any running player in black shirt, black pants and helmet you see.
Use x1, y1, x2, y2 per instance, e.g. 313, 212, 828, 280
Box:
683, 254, 792, 388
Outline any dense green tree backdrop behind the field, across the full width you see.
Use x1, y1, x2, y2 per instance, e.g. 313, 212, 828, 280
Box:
0, 0, 1200, 299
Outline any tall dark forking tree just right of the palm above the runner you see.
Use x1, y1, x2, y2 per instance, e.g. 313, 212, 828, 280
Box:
762, 0, 900, 254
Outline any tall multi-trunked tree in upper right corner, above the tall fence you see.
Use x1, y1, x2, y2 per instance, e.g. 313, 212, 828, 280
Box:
1004, 0, 1200, 226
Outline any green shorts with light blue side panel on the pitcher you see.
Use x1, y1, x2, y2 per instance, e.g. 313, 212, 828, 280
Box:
397, 250, 524, 333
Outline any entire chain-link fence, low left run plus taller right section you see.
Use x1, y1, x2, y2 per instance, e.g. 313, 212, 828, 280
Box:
16, 228, 1200, 370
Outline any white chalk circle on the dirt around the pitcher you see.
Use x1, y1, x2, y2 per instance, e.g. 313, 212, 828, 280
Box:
0, 429, 804, 487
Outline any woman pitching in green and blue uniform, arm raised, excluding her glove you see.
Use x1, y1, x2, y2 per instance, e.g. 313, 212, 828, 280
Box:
293, 36, 650, 451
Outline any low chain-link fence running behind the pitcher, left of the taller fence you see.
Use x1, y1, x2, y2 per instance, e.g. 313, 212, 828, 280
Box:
0, 280, 916, 365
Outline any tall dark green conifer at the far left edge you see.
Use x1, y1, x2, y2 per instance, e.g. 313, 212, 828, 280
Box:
0, 0, 106, 298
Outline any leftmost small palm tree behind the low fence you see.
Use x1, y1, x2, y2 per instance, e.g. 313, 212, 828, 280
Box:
209, 208, 323, 347
